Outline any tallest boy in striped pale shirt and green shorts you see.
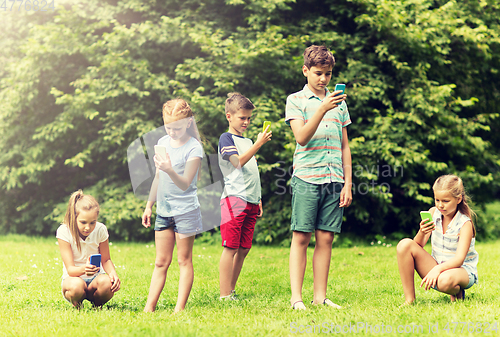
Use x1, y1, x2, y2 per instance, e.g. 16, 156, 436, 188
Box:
285, 45, 352, 310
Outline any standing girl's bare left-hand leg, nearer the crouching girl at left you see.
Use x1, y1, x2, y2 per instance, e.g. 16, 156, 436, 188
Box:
144, 228, 175, 312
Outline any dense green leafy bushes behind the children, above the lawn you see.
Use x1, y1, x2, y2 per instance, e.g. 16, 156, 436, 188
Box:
0, 0, 500, 244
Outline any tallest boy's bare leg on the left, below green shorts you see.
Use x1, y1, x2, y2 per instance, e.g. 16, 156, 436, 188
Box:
289, 231, 312, 305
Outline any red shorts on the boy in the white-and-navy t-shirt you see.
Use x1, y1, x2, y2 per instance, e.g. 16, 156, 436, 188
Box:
220, 196, 259, 249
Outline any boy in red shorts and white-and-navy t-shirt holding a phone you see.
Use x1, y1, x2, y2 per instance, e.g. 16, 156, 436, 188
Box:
218, 93, 272, 300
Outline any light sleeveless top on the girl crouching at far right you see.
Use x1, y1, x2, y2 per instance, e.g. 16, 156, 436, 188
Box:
431, 209, 479, 280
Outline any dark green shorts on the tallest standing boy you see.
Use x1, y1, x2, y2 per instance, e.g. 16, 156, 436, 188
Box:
291, 176, 344, 233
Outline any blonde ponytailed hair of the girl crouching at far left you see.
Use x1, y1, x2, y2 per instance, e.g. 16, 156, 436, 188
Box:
64, 190, 100, 252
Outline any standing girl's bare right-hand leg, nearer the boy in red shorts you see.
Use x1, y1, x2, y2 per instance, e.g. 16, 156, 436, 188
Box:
174, 234, 195, 312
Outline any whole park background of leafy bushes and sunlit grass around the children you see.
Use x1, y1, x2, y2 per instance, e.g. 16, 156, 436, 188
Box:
0, 0, 500, 336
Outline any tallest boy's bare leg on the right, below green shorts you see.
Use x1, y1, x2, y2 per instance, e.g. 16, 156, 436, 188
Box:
313, 229, 335, 304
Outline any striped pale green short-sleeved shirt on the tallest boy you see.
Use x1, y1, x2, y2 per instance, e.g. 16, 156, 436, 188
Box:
285, 84, 351, 185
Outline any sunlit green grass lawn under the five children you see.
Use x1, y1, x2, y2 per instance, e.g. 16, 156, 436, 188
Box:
0, 236, 500, 337
